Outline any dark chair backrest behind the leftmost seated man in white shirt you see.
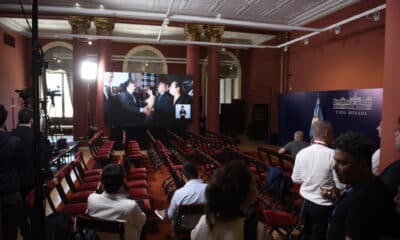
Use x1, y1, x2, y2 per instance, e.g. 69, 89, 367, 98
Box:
76, 215, 125, 240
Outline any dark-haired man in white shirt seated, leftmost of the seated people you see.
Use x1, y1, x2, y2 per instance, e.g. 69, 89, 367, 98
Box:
87, 163, 146, 240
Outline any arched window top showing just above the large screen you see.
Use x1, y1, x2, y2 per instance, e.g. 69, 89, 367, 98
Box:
122, 45, 168, 74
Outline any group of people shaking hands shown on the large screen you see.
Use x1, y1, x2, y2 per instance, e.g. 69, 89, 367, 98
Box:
104, 77, 192, 125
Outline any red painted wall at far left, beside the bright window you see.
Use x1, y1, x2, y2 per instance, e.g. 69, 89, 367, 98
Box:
0, 28, 30, 130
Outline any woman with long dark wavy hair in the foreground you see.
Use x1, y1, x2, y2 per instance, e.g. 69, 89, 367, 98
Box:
191, 161, 268, 240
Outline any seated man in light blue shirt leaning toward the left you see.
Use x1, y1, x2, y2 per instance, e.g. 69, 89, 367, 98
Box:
155, 162, 207, 219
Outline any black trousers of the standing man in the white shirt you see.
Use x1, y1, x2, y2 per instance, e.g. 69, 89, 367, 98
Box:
303, 199, 333, 240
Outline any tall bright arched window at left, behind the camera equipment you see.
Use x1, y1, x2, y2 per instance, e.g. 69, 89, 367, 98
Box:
41, 41, 73, 121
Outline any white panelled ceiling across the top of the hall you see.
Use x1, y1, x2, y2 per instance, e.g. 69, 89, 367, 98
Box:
0, 0, 358, 45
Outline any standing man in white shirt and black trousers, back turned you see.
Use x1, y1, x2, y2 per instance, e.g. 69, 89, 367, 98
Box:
292, 121, 344, 240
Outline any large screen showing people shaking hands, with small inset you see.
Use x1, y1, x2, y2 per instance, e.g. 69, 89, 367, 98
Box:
104, 72, 193, 127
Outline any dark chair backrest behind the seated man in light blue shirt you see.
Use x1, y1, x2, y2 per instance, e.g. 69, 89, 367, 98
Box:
174, 204, 205, 232
